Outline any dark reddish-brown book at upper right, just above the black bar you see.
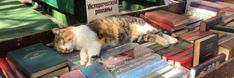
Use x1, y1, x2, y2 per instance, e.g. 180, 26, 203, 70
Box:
200, 15, 223, 31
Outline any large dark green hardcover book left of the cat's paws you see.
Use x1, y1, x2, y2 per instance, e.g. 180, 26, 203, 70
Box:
7, 43, 67, 78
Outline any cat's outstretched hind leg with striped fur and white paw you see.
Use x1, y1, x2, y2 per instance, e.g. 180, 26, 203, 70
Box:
138, 33, 178, 46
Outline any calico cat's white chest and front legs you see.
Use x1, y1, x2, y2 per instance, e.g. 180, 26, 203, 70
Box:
72, 25, 101, 66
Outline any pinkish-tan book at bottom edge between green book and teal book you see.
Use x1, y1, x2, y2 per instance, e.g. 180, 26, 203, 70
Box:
39, 66, 69, 78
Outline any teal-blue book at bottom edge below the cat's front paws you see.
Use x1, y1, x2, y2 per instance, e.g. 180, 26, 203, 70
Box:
80, 63, 115, 78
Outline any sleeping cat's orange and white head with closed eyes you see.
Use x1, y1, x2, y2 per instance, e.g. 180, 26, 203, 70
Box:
52, 27, 75, 53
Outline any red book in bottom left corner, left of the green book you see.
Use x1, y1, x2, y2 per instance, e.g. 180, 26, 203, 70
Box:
0, 58, 16, 78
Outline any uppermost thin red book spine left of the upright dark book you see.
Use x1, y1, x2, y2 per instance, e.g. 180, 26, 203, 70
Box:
162, 44, 193, 60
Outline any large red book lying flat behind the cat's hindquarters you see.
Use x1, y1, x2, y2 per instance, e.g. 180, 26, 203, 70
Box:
141, 10, 189, 32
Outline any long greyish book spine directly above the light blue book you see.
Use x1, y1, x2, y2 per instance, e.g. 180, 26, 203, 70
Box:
113, 53, 160, 75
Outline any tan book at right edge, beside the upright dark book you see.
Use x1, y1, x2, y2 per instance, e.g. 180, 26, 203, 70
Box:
218, 38, 234, 60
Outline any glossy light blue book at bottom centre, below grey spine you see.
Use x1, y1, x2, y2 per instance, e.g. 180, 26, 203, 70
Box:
116, 60, 168, 78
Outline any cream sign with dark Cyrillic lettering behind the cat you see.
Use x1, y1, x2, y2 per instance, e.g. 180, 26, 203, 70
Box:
86, 0, 119, 22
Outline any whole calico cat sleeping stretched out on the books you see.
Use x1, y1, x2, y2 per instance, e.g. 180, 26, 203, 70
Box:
52, 16, 177, 66
